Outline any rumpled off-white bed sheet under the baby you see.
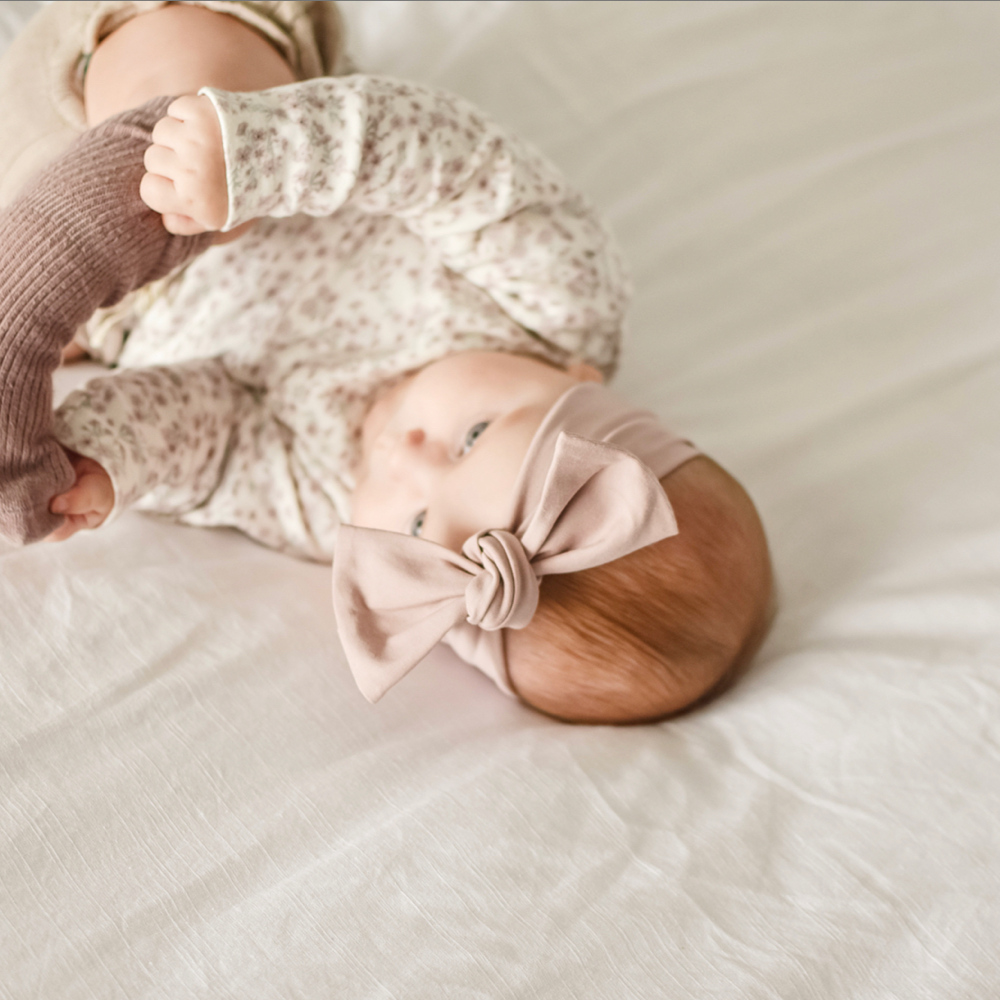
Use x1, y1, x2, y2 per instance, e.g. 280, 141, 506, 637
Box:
0, 0, 1000, 1000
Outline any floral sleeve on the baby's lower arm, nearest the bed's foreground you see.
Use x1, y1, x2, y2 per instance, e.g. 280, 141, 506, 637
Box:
55, 359, 337, 560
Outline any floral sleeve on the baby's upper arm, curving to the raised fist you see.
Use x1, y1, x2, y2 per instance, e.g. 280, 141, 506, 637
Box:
203, 75, 630, 373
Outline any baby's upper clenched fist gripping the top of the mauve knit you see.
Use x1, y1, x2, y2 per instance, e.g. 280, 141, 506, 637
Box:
139, 96, 229, 236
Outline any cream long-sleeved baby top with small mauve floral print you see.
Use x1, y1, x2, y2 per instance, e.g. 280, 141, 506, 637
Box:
57, 75, 628, 560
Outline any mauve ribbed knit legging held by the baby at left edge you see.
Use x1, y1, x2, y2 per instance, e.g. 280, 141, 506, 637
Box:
0, 98, 211, 544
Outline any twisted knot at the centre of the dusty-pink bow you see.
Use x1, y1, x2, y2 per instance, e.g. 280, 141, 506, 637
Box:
462, 529, 538, 632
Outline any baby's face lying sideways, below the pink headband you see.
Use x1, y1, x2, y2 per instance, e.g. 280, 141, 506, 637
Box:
352, 351, 600, 551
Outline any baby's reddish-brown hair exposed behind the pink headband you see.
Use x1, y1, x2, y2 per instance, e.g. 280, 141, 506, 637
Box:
506, 457, 773, 723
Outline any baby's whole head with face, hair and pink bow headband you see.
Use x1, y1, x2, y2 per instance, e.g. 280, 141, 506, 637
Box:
334, 352, 773, 723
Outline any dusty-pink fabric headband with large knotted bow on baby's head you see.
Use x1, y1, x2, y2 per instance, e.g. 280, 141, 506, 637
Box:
333, 384, 698, 701
